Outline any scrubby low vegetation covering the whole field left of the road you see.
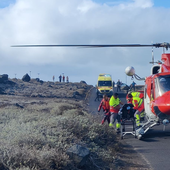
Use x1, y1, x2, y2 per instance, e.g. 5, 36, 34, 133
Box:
0, 80, 148, 170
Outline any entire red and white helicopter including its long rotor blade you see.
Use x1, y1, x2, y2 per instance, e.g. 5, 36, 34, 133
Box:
12, 42, 170, 139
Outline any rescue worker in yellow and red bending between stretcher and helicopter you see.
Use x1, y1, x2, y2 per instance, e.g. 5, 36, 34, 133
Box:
128, 94, 144, 129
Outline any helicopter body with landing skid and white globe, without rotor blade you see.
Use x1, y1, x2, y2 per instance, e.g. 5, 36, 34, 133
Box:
125, 49, 170, 139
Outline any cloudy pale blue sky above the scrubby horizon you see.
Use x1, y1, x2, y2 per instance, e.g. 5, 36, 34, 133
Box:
0, 0, 170, 85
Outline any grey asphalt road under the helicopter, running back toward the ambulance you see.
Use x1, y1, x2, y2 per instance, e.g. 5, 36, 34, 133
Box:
88, 89, 170, 170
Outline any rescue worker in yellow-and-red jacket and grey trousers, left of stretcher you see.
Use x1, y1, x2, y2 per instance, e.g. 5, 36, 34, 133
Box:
109, 93, 123, 133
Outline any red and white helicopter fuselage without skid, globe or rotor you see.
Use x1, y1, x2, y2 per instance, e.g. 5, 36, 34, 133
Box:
144, 54, 170, 121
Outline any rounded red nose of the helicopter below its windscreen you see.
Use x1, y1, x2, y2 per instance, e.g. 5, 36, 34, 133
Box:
155, 91, 170, 115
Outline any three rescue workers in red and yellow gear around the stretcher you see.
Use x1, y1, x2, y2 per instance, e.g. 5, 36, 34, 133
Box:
98, 92, 144, 133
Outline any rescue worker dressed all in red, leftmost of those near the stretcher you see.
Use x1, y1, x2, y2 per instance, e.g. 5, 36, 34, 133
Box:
98, 94, 110, 124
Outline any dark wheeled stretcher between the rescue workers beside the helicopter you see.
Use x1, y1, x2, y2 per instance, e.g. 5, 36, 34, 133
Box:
119, 104, 136, 139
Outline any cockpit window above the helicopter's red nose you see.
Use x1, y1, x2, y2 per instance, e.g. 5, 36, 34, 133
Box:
155, 76, 170, 96
